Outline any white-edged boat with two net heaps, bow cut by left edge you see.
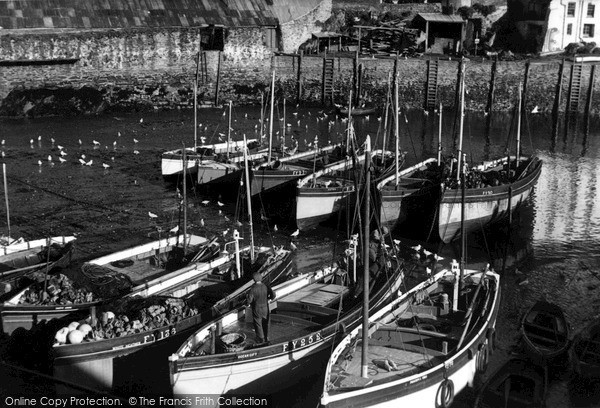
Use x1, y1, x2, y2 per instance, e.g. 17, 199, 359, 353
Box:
0, 234, 218, 334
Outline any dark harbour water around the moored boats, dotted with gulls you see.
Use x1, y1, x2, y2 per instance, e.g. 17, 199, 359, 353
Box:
0, 107, 600, 407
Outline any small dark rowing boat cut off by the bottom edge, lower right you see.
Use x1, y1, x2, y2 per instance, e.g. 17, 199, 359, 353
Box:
475, 358, 548, 408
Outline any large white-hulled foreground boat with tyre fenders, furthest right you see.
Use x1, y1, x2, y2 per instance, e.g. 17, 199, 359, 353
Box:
321, 263, 500, 407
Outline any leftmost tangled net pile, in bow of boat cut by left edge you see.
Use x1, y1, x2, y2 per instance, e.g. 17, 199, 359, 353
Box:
19, 274, 96, 305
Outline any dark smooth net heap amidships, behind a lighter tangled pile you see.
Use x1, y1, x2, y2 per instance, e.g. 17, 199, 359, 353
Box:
81, 263, 133, 299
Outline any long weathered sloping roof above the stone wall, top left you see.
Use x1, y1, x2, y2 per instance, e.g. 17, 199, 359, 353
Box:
0, 0, 290, 30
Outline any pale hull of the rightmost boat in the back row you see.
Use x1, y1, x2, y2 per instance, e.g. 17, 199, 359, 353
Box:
438, 161, 542, 243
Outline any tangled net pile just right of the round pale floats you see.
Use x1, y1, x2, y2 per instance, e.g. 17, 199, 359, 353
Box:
88, 296, 198, 340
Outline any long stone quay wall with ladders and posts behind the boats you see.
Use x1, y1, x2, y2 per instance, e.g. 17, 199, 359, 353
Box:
0, 27, 600, 116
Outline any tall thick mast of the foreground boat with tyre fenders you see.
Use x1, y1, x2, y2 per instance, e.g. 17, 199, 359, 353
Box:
361, 135, 371, 378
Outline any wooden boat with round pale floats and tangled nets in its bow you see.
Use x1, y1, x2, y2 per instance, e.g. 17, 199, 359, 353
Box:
51, 242, 292, 391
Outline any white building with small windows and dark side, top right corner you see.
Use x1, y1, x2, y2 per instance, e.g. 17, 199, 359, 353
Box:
508, 0, 600, 53
